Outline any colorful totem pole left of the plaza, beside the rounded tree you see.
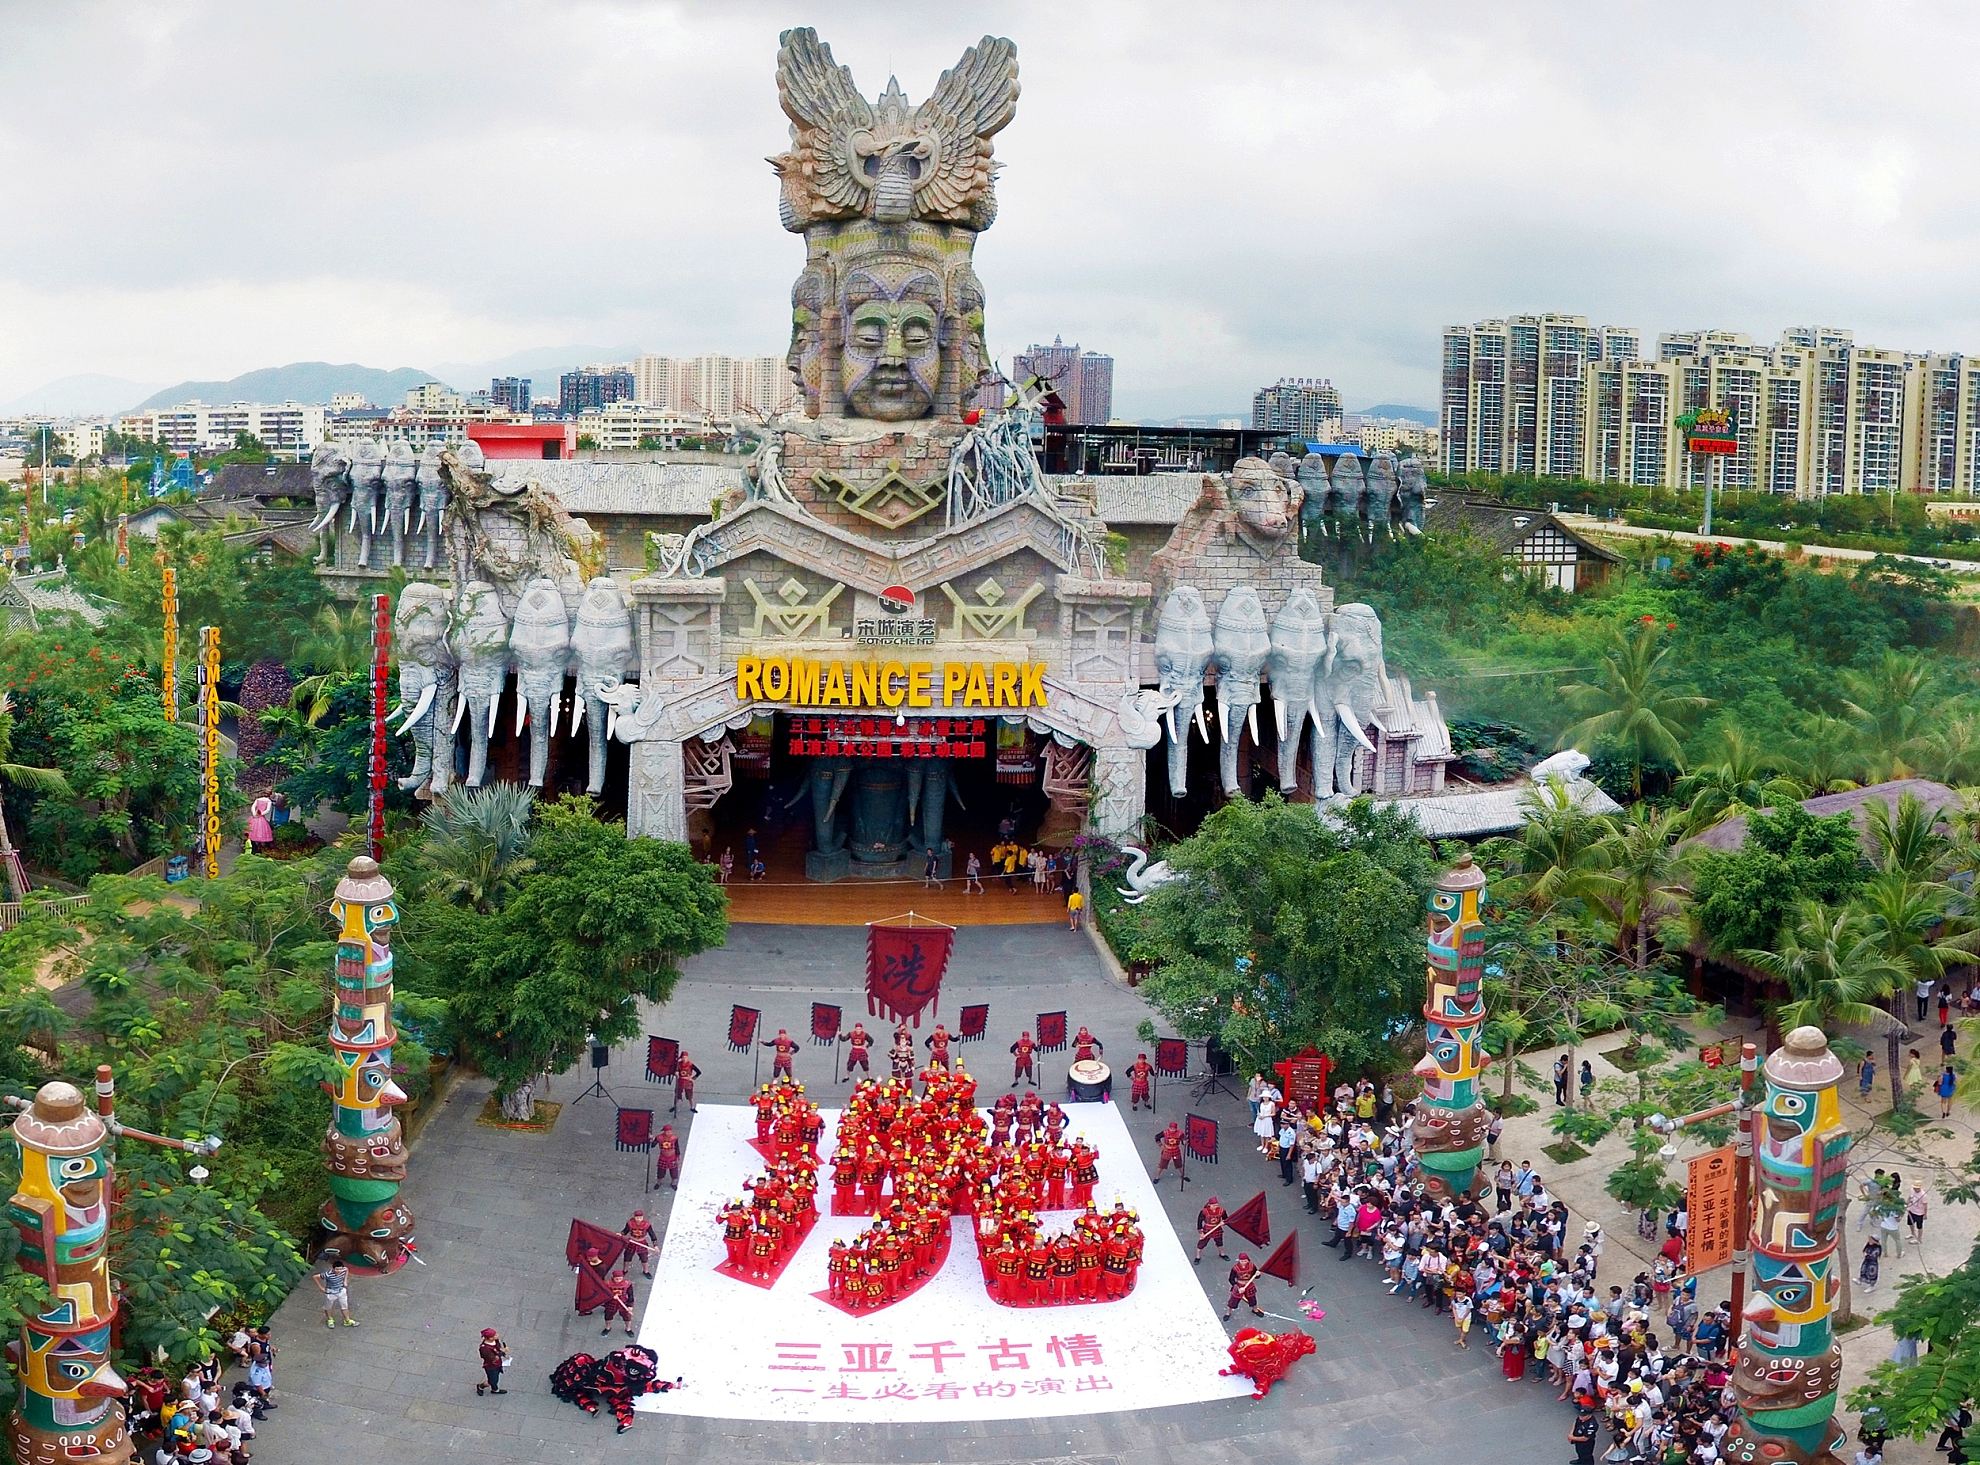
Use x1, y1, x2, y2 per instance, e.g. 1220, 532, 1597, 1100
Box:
317, 855, 412, 1271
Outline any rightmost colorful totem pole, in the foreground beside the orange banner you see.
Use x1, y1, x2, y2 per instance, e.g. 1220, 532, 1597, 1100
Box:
1721, 1027, 1849, 1465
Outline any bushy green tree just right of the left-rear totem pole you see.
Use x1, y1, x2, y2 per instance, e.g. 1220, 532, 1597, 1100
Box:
402, 798, 729, 1119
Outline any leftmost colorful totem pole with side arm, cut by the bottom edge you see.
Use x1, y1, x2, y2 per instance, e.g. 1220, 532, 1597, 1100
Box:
6, 1067, 220, 1465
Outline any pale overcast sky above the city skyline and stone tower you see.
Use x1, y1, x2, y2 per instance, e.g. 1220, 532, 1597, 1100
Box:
0, 0, 1980, 416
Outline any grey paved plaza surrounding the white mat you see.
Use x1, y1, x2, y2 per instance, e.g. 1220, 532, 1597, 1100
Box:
255, 927, 1568, 1465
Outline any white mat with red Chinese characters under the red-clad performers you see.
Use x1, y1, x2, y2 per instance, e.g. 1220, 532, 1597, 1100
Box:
640, 1103, 1251, 1423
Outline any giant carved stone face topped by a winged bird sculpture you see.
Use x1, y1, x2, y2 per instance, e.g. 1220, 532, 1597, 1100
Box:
770, 30, 1018, 422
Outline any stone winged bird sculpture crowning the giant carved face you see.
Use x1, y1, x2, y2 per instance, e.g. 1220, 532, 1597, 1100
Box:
770, 28, 1018, 234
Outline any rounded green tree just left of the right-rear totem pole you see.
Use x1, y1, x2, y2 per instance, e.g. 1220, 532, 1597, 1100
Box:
1129, 794, 1436, 1069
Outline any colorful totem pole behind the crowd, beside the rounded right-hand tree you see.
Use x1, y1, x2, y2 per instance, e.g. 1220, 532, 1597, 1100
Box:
1410, 855, 1491, 1200
